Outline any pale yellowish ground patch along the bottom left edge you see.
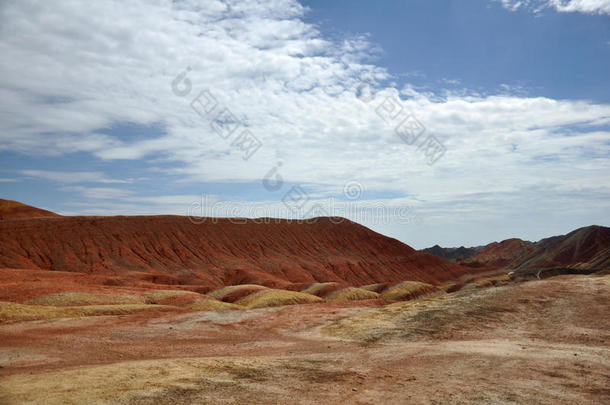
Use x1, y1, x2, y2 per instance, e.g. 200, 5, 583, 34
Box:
0, 356, 358, 405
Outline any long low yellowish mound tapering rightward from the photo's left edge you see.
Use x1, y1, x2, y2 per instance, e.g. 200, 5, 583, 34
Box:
0, 302, 178, 323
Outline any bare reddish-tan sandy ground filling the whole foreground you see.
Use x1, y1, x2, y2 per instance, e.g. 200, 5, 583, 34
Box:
0, 276, 610, 405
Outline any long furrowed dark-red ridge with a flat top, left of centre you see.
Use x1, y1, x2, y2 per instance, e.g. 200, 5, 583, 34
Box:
0, 216, 471, 292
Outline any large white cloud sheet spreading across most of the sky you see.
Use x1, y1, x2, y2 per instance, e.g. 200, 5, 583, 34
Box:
0, 0, 610, 246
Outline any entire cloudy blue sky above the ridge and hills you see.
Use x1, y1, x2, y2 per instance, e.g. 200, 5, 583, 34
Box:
0, 0, 610, 248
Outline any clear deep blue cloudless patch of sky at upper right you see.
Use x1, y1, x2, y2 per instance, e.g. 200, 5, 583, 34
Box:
304, 0, 610, 103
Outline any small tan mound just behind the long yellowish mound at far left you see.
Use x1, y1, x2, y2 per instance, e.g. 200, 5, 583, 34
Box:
25, 292, 145, 307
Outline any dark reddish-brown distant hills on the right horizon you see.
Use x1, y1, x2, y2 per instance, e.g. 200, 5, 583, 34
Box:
423, 225, 610, 269
